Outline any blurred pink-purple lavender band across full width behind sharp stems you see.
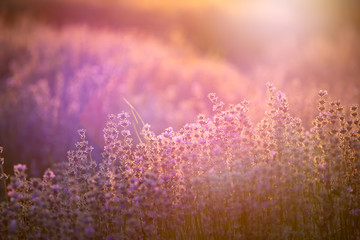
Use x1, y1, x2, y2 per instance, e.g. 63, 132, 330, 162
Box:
0, 17, 360, 177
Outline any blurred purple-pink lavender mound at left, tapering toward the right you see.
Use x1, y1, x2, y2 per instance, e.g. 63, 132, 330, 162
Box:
0, 19, 250, 176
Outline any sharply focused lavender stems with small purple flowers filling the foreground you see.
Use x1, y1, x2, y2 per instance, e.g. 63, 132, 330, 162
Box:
0, 85, 360, 239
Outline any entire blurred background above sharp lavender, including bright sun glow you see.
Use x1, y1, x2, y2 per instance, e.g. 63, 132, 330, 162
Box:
0, 0, 360, 176
